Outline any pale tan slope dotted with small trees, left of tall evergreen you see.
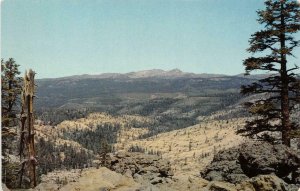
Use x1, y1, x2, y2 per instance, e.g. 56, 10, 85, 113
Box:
120, 118, 245, 176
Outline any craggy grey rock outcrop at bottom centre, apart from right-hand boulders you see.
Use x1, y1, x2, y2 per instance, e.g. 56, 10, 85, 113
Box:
105, 152, 173, 184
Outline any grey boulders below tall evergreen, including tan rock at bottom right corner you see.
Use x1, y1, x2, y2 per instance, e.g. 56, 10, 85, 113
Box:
201, 142, 300, 191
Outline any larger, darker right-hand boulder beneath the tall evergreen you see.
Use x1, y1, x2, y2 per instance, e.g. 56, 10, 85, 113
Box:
238, 142, 300, 183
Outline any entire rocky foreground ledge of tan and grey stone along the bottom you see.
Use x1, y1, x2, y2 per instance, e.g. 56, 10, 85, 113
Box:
3, 142, 300, 191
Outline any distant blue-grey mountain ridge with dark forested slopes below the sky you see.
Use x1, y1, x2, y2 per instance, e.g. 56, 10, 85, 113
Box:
35, 69, 274, 124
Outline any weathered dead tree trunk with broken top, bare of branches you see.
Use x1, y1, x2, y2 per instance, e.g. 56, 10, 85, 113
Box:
19, 69, 37, 188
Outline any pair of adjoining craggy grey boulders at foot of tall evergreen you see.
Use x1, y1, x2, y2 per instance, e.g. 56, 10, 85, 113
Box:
201, 142, 300, 184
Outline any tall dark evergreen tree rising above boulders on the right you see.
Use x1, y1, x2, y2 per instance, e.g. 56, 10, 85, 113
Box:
238, 0, 300, 146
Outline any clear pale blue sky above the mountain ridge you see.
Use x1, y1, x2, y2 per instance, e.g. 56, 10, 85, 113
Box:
1, 0, 299, 78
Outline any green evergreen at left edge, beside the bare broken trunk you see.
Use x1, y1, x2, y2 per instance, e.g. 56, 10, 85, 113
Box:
1, 58, 21, 188
